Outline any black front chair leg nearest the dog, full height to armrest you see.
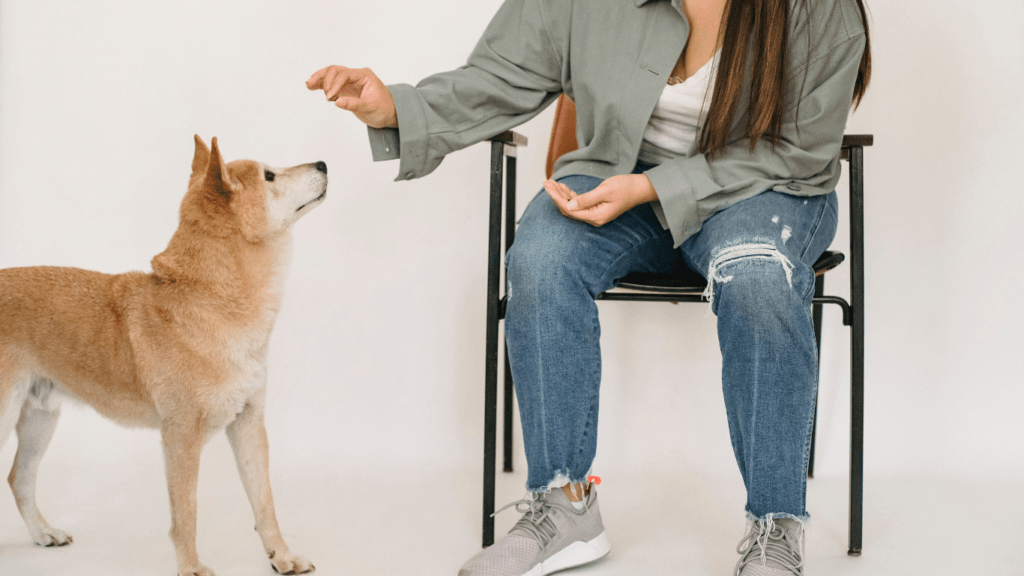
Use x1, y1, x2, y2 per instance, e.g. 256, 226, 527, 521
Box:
483, 142, 504, 547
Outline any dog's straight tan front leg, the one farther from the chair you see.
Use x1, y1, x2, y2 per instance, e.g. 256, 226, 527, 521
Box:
160, 418, 214, 576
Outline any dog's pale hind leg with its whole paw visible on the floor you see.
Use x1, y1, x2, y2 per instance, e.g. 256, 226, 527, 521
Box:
7, 378, 72, 546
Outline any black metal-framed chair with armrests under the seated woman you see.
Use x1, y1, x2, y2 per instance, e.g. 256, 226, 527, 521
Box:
483, 126, 874, 556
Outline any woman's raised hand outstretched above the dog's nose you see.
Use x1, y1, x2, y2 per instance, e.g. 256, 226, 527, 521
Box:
306, 66, 398, 128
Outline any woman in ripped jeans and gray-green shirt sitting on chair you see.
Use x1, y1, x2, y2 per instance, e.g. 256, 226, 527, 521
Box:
306, 0, 870, 576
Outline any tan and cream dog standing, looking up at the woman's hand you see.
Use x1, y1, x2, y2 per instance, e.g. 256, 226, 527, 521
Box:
0, 135, 327, 576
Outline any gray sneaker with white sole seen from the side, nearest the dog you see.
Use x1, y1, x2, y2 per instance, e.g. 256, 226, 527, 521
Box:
459, 488, 611, 576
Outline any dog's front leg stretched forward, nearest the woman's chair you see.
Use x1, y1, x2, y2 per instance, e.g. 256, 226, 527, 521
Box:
226, 398, 315, 574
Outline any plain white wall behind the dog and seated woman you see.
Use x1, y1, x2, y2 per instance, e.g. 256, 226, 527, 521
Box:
0, 0, 1024, 569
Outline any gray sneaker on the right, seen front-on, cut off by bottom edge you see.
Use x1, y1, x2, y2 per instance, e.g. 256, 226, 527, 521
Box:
733, 518, 804, 576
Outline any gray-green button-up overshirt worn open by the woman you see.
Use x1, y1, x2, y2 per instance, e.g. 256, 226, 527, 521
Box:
370, 0, 865, 246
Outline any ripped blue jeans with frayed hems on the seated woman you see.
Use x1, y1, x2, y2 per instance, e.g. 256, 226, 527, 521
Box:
505, 167, 838, 521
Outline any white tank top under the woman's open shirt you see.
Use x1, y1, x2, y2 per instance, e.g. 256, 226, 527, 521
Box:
637, 53, 718, 164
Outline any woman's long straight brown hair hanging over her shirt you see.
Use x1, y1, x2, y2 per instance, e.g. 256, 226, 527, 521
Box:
699, 0, 871, 157
